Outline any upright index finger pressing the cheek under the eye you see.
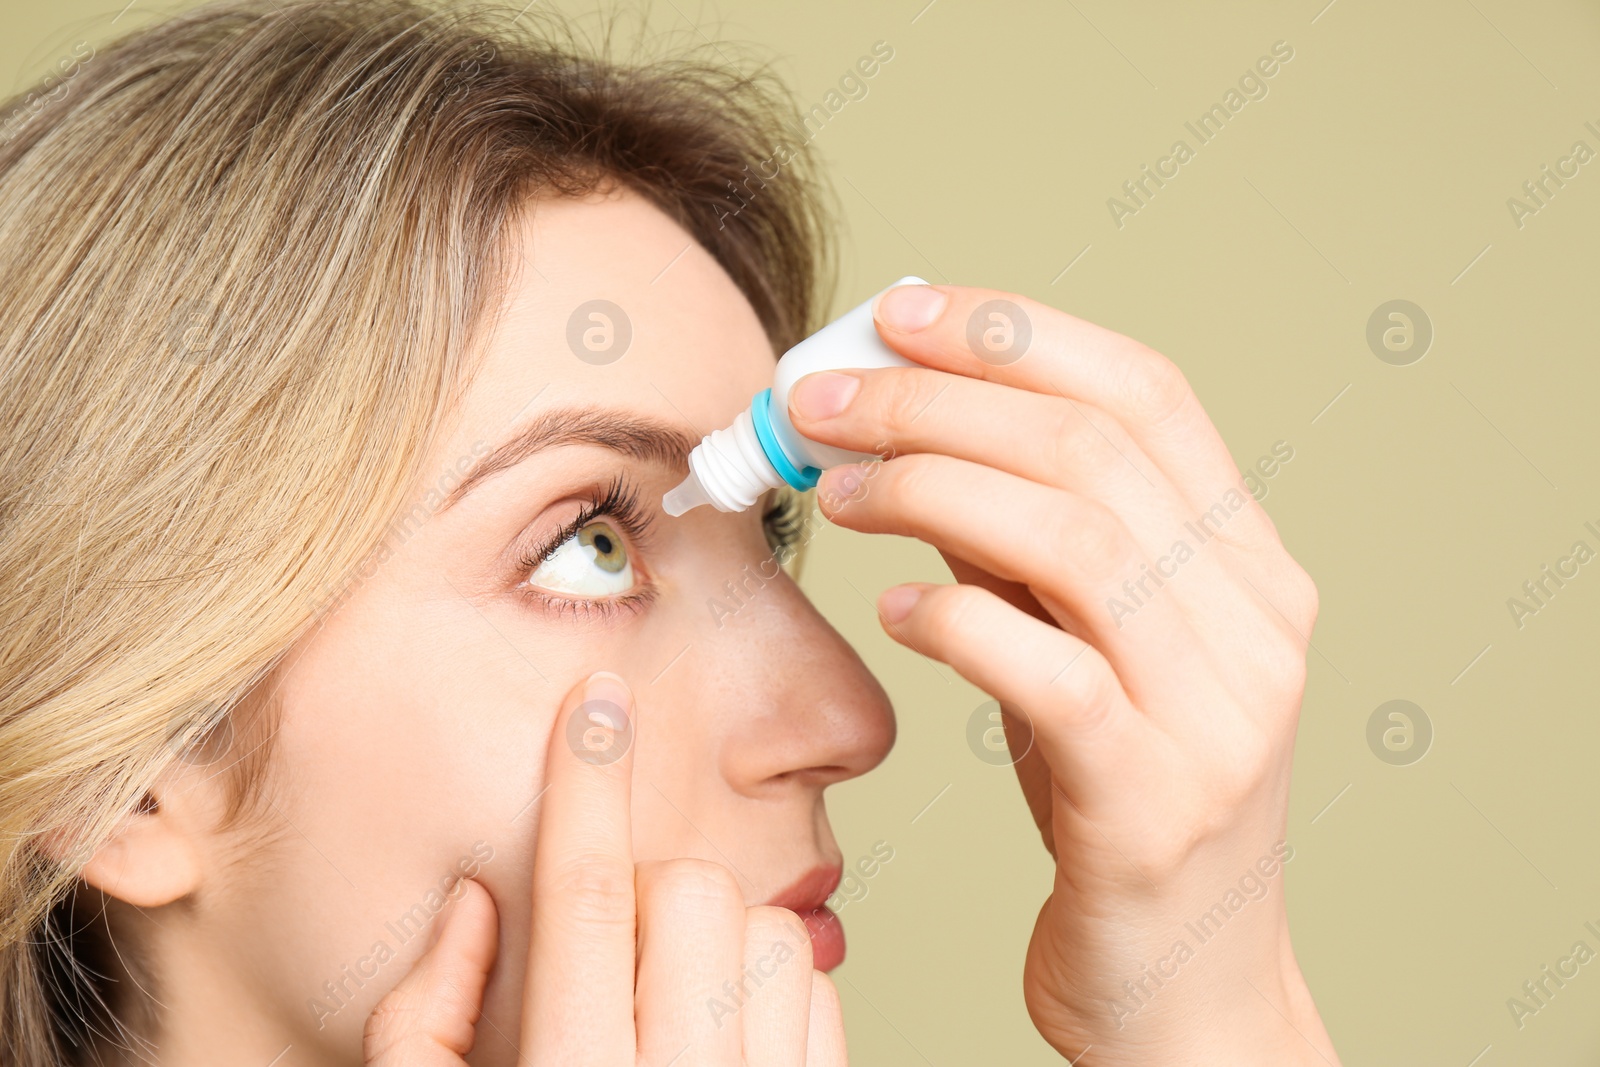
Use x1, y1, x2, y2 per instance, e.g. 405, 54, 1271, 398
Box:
522, 670, 637, 1067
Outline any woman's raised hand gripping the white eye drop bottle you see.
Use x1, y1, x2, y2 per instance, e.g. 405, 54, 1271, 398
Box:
790, 286, 1336, 1065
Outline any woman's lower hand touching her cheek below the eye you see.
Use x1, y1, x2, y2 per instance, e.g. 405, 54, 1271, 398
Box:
363, 672, 845, 1067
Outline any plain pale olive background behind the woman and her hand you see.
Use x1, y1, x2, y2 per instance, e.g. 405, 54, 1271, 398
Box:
12, 0, 1600, 1067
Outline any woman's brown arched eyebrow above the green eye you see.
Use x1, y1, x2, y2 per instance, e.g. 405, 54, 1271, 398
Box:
438, 408, 699, 510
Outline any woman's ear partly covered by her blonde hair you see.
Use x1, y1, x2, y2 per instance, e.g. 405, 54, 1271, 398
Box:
43, 760, 221, 907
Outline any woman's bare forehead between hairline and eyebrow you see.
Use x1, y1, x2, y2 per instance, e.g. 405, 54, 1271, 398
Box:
464, 192, 774, 445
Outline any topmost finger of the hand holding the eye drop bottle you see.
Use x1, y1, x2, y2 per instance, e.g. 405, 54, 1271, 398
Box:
872, 285, 1277, 544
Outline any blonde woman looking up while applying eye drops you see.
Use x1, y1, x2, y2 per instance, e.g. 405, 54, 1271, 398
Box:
0, 0, 1334, 1067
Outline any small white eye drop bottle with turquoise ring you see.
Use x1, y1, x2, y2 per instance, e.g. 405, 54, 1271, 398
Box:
661, 277, 928, 515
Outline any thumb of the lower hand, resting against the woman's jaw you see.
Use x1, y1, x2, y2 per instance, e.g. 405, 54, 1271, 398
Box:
362, 880, 498, 1067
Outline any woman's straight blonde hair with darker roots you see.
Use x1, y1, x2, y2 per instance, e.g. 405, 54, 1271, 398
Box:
0, 0, 832, 1067
